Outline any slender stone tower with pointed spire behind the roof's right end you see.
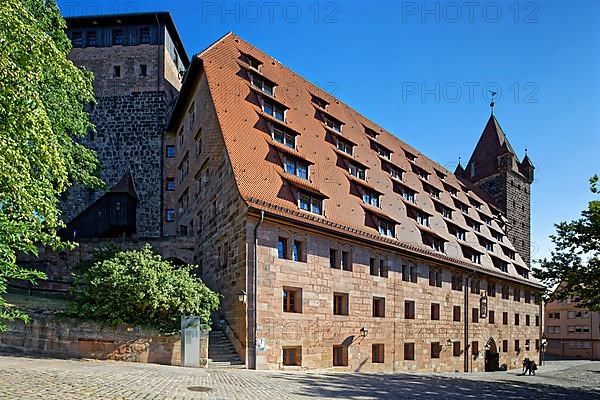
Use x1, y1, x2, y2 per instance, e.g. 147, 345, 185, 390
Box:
456, 114, 534, 265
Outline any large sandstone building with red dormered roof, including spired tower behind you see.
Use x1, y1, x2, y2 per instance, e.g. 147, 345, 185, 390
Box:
164, 33, 542, 371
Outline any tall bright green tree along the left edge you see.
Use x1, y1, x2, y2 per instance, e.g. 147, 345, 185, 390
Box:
0, 0, 101, 330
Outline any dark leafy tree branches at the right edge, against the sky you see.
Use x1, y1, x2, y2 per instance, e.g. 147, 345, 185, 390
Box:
533, 175, 600, 311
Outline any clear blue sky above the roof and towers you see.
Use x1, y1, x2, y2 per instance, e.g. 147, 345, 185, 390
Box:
58, 0, 600, 258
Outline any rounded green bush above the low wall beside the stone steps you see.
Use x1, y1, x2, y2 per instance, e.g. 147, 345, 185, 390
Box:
69, 244, 219, 332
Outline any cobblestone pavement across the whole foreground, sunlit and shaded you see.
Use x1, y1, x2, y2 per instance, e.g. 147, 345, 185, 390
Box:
0, 356, 600, 400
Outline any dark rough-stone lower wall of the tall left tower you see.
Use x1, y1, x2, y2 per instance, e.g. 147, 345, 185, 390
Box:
61, 92, 169, 237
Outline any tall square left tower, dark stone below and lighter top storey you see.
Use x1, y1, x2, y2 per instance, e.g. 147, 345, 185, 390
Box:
61, 12, 189, 238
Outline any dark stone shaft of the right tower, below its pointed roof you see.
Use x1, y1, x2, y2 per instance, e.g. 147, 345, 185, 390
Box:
476, 171, 531, 265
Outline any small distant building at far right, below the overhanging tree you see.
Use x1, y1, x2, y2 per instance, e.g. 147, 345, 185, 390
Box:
544, 298, 600, 360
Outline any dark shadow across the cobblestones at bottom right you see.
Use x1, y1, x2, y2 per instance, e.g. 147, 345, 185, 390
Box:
275, 373, 600, 400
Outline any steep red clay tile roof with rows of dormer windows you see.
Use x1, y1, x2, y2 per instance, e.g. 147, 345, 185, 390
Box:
196, 33, 538, 285
